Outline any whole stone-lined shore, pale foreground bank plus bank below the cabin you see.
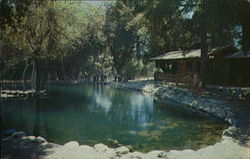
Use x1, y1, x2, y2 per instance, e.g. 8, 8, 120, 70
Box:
1, 81, 250, 159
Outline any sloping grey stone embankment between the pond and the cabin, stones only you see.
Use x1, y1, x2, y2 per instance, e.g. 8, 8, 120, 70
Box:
110, 81, 238, 125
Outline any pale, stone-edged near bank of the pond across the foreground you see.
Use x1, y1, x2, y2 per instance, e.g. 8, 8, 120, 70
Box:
1, 127, 250, 159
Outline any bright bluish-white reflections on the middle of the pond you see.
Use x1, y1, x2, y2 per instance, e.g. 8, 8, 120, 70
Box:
89, 85, 153, 130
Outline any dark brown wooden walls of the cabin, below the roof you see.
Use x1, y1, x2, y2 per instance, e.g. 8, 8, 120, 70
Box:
153, 58, 250, 87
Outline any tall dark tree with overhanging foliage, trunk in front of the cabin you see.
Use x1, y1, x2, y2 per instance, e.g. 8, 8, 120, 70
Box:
192, 0, 250, 86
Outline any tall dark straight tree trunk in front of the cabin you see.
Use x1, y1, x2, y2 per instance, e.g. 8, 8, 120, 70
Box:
200, 16, 208, 87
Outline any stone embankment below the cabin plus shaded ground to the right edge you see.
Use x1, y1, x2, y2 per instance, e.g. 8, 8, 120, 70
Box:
110, 81, 250, 137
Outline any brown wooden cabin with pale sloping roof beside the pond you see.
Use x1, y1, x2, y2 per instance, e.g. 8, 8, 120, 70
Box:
150, 46, 250, 86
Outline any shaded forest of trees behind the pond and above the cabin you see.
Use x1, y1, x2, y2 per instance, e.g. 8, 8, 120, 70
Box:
0, 0, 250, 91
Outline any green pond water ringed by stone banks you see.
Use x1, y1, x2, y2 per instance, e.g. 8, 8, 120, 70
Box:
1, 85, 226, 152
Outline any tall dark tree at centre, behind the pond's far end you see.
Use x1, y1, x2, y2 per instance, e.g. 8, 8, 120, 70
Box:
105, 1, 142, 75
